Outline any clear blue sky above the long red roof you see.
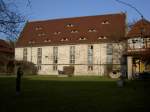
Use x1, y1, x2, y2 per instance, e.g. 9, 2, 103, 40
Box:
16, 0, 150, 22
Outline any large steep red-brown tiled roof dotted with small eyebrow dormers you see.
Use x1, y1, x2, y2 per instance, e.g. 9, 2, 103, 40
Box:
16, 13, 126, 47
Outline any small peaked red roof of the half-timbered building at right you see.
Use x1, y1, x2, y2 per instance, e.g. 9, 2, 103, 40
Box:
127, 19, 150, 38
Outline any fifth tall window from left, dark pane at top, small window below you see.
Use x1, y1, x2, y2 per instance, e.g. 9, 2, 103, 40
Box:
88, 45, 93, 70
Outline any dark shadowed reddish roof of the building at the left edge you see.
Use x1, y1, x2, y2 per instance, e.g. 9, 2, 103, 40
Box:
0, 39, 13, 53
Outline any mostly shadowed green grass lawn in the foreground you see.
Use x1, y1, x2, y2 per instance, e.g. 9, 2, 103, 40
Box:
0, 76, 150, 112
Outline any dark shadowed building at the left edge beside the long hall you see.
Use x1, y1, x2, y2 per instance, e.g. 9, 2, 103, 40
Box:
0, 39, 14, 73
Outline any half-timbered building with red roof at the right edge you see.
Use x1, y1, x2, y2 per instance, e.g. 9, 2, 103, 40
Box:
127, 18, 150, 78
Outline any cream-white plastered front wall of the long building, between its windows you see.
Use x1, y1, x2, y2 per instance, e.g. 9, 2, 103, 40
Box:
15, 43, 124, 76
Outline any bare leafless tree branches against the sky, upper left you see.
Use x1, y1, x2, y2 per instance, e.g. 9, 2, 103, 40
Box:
0, 0, 30, 41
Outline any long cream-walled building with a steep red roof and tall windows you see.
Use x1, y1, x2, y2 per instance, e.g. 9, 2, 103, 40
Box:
15, 13, 126, 76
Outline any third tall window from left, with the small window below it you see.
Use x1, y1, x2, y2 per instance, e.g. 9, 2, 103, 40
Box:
53, 46, 58, 71
